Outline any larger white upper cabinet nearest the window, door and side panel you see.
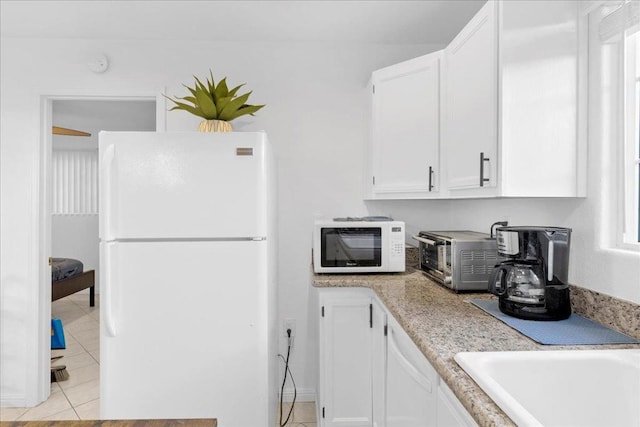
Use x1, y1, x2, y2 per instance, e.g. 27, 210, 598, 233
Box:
443, 0, 586, 197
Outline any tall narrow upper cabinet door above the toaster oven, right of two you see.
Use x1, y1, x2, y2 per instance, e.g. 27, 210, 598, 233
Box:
443, 1, 498, 192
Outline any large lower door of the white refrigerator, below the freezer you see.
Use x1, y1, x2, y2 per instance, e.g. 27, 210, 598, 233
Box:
100, 241, 276, 427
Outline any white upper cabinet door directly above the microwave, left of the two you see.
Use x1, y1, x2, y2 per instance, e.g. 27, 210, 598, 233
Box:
370, 51, 443, 198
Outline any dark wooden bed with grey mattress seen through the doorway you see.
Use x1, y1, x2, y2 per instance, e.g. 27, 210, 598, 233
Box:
51, 258, 95, 307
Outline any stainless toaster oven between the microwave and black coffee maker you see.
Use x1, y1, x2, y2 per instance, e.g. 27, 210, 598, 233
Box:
412, 231, 503, 292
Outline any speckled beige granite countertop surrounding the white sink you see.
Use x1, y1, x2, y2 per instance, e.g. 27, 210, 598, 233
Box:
312, 268, 640, 426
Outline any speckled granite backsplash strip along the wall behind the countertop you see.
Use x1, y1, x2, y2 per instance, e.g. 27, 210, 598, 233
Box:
405, 246, 640, 339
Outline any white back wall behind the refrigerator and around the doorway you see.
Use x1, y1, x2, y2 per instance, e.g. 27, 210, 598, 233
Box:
0, 38, 441, 405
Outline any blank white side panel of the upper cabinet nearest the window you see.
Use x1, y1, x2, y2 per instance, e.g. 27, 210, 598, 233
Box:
499, 1, 586, 197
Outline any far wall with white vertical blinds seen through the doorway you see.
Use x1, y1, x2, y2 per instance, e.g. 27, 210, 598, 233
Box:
50, 100, 156, 293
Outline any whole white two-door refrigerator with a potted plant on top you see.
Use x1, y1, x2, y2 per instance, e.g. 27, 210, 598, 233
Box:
99, 132, 278, 427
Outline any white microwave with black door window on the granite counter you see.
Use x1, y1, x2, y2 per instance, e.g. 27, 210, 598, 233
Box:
313, 221, 405, 273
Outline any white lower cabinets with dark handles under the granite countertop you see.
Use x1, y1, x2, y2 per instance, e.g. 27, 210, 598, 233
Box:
318, 288, 477, 427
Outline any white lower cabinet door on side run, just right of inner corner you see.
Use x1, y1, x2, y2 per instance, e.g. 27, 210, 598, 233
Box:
386, 323, 437, 427
